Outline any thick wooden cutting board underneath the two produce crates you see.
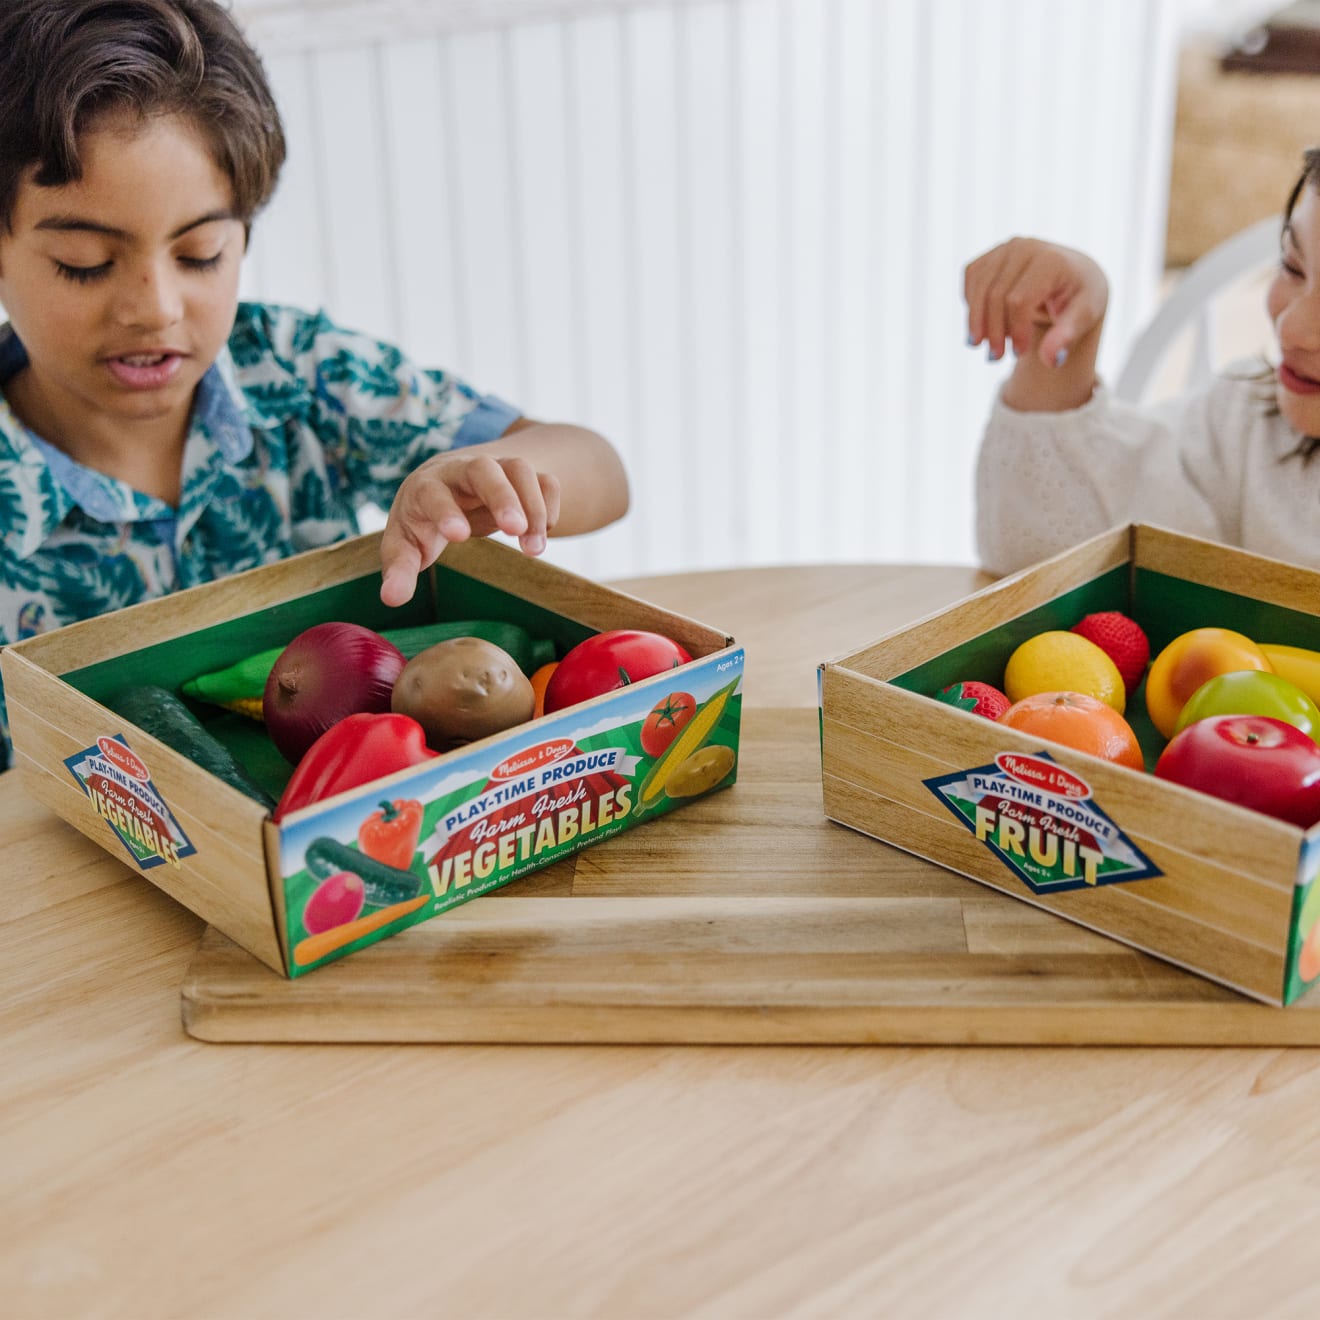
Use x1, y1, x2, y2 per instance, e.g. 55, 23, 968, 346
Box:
182, 709, 1320, 1045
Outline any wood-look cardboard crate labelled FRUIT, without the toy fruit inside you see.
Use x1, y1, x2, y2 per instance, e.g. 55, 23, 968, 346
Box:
820, 525, 1320, 1005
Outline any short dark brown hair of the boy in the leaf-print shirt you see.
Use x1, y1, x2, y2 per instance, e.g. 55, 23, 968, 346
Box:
0, 0, 284, 231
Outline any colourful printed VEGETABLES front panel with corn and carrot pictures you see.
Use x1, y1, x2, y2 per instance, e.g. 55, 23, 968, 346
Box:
270, 651, 743, 975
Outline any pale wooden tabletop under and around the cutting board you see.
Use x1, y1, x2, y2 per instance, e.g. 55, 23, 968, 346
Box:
10, 568, 1320, 1317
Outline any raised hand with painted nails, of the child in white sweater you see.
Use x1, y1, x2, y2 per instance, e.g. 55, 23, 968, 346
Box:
962, 238, 1109, 367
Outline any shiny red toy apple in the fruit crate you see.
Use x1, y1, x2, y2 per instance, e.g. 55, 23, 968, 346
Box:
1155, 715, 1320, 829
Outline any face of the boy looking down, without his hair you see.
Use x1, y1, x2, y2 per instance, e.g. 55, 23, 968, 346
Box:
0, 110, 246, 444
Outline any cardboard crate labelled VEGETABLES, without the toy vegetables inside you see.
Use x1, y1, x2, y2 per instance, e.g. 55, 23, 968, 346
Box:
0, 533, 743, 977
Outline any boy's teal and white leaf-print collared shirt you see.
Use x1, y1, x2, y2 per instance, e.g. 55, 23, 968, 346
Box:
0, 302, 519, 770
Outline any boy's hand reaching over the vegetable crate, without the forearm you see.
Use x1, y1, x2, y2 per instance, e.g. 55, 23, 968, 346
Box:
380, 445, 560, 606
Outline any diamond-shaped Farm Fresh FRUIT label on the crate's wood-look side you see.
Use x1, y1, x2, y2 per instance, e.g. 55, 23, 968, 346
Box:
923, 751, 1163, 894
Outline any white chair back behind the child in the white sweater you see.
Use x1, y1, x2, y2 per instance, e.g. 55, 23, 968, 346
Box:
1113, 216, 1279, 403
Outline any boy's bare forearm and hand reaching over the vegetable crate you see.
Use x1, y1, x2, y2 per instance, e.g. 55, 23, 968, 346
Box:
380, 418, 628, 606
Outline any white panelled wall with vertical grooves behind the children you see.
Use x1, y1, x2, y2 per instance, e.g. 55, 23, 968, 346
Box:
20, 0, 1187, 576
